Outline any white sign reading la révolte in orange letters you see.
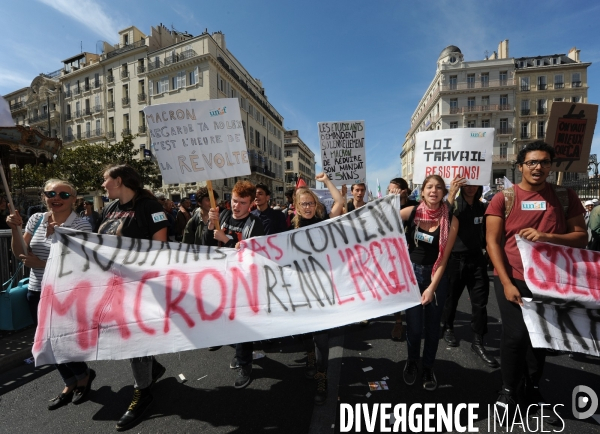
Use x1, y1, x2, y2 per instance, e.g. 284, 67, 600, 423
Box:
144, 98, 251, 184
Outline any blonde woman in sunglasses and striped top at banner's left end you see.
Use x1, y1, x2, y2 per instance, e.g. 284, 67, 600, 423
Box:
6, 179, 96, 410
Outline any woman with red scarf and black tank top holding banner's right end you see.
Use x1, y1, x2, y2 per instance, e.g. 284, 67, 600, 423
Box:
400, 175, 458, 391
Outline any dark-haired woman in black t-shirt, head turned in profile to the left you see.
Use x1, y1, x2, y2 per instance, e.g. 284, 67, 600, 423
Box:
98, 164, 168, 431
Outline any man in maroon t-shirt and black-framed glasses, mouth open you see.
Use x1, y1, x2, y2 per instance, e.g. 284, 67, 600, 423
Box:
485, 141, 587, 423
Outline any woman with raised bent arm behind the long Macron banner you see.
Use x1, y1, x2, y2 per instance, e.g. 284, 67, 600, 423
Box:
292, 173, 345, 405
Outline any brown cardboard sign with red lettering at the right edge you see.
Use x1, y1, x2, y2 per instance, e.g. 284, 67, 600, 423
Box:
546, 102, 598, 173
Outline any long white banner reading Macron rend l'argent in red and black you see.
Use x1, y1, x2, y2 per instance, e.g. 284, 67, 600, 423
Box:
33, 196, 420, 365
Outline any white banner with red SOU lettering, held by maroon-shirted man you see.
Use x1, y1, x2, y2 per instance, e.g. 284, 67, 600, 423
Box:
517, 236, 600, 356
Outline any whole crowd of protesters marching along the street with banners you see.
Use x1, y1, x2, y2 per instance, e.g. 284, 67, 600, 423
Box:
0, 142, 600, 430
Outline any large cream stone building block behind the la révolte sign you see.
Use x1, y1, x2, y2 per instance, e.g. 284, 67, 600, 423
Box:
5, 24, 284, 201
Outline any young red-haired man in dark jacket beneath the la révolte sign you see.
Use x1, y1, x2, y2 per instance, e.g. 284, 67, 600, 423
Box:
203, 181, 265, 389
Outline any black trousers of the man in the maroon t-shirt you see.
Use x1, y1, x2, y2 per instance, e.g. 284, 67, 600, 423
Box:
494, 276, 546, 392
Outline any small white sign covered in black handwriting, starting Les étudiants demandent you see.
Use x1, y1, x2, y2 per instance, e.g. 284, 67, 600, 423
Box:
318, 121, 367, 186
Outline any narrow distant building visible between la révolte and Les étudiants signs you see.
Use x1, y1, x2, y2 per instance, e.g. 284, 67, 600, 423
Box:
284, 130, 317, 190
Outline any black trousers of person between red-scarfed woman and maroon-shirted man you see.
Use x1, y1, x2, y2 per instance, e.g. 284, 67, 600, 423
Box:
442, 253, 490, 335
